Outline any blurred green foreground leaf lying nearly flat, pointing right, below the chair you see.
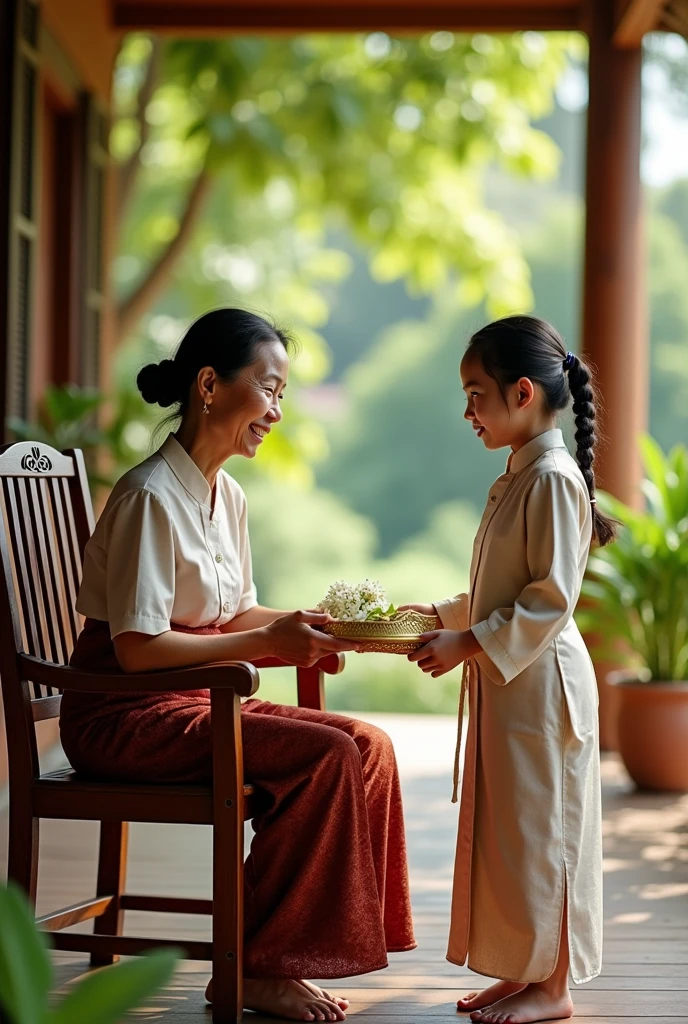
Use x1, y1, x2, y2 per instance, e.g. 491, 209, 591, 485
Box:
49, 949, 181, 1024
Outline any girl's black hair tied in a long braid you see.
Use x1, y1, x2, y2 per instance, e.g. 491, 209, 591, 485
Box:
468, 315, 617, 547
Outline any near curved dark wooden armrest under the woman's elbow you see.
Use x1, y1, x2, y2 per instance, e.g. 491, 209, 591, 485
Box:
17, 654, 259, 697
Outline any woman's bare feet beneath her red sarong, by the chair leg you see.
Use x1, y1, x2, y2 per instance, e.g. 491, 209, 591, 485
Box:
206, 978, 349, 1021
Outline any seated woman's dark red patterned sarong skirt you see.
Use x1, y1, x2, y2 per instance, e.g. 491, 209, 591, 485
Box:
60, 620, 416, 978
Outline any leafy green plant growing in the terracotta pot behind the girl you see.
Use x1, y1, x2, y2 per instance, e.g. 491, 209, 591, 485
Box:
576, 437, 688, 682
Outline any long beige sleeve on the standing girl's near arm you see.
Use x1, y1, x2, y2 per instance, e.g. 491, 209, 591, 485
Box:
471, 473, 586, 685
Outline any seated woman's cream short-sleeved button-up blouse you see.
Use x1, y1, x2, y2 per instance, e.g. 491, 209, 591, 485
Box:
77, 434, 257, 637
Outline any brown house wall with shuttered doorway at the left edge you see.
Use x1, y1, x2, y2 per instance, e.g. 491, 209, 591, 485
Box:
0, 0, 116, 786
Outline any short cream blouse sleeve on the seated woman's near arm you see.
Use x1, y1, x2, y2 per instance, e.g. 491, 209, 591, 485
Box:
105, 489, 175, 637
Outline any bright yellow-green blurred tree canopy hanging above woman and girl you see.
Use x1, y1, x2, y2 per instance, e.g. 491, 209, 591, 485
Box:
113, 32, 575, 337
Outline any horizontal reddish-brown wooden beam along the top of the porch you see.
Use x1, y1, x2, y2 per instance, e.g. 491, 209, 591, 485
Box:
112, 0, 582, 35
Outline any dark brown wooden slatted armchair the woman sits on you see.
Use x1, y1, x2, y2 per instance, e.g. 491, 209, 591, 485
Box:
0, 442, 344, 1024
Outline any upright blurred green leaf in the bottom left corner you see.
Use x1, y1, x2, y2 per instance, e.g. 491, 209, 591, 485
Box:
0, 882, 52, 1024
